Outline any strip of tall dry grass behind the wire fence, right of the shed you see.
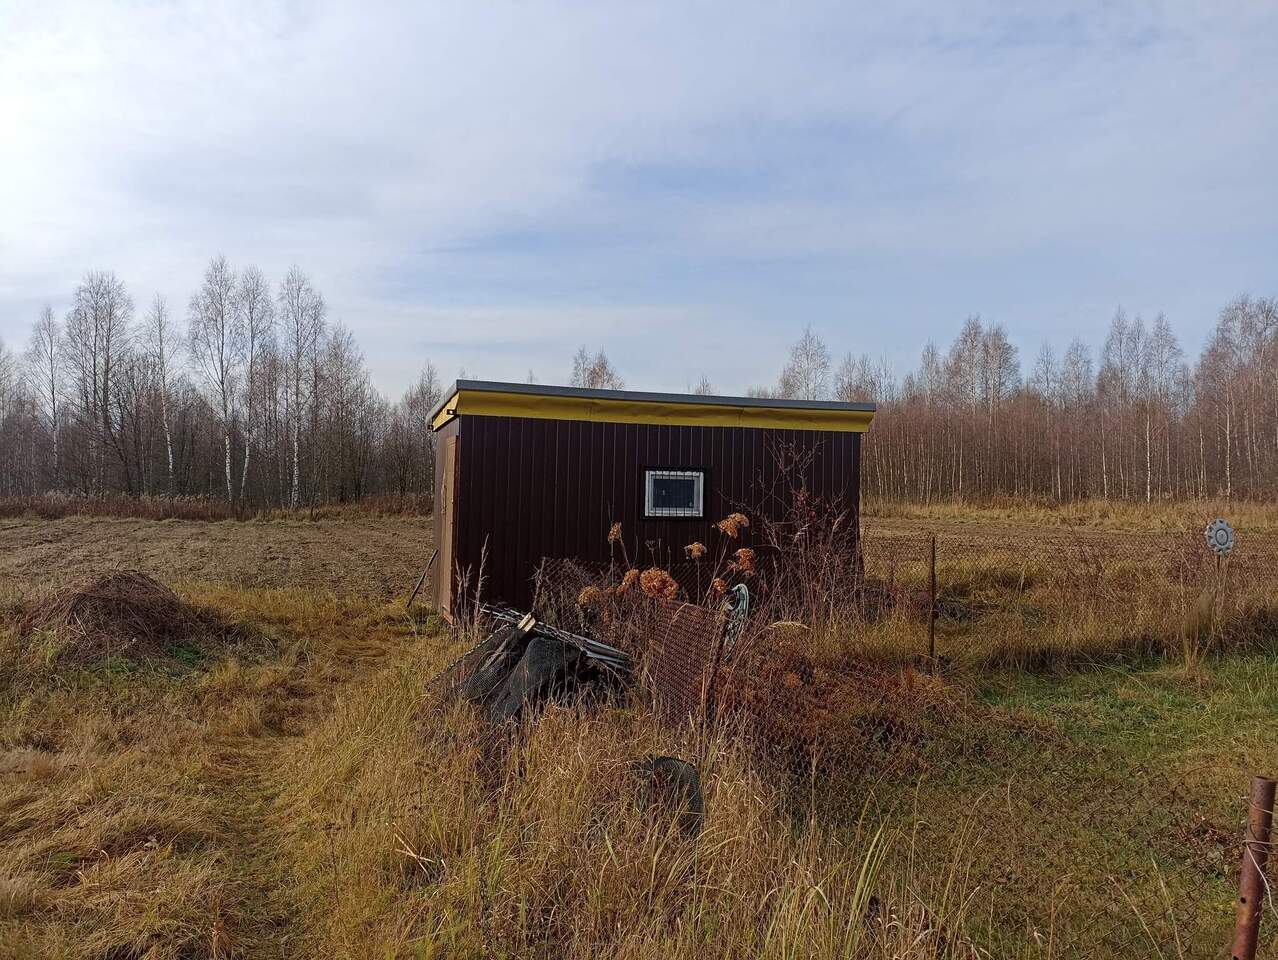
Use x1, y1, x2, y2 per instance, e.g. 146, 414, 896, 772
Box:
848, 545, 1278, 675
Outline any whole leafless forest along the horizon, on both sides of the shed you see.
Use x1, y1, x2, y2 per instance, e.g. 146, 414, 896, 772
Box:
0, 257, 1278, 507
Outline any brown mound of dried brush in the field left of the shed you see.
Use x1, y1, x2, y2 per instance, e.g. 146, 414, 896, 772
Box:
19, 570, 242, 665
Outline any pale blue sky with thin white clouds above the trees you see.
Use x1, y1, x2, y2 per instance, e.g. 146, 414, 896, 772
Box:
0, 0, 1278, 395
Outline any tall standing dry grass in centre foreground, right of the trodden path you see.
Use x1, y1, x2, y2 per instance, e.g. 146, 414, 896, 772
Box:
280, 641, 1022, 960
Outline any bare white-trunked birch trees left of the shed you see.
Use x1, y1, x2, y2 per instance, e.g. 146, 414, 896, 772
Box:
0, 257, 441, 507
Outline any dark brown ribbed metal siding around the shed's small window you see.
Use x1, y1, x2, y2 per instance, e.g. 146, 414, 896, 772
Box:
447, 415, 860, 607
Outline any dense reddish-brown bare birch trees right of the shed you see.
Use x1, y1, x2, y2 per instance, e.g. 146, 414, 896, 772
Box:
750, 297, 1278, 501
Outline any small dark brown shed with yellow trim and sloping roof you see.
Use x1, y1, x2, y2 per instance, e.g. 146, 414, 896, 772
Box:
431, 380, 874, 615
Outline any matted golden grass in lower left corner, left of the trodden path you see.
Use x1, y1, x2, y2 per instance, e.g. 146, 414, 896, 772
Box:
0, 649, 248, 960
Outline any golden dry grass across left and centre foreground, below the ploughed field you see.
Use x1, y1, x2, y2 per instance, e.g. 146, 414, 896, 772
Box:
0, 567, 1037, 960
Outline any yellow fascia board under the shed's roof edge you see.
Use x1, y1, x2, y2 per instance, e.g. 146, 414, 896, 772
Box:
431, 390, 874, 433
